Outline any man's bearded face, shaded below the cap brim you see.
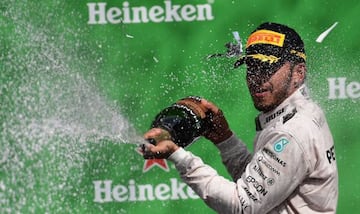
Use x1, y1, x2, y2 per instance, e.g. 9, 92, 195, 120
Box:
246, 62, 294, 112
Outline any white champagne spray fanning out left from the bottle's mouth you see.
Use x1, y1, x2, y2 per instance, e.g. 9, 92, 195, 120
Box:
0, 1, 142, 213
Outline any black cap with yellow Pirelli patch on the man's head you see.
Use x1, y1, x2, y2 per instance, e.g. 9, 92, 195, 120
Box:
235, 22, 306, 71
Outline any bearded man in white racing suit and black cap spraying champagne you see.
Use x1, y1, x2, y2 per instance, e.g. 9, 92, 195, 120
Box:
144, 23, 338, 214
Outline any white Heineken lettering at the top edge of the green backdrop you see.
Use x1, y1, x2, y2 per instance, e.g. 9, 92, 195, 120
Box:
87, 0, 214, 25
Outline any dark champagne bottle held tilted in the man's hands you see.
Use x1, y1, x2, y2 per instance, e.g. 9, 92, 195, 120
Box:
148, 96, 211, 147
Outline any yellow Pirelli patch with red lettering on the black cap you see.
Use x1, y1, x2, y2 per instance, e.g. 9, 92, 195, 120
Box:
246, 30, 285, 47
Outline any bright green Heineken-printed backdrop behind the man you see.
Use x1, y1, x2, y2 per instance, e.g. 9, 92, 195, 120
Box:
0, 0, 360, 213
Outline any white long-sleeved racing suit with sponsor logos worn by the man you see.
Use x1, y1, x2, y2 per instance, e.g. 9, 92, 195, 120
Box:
169, 86, 338, 214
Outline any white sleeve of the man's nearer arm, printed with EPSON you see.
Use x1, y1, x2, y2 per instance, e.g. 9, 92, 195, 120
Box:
169, 132, 308, 213
